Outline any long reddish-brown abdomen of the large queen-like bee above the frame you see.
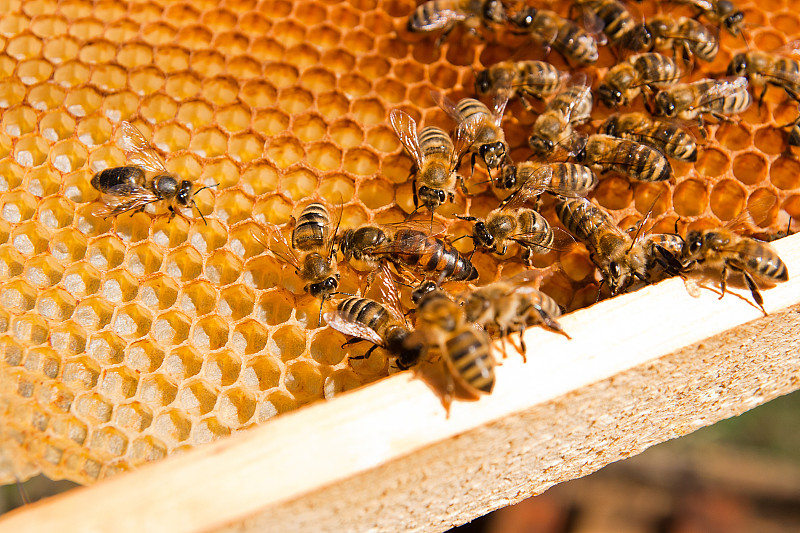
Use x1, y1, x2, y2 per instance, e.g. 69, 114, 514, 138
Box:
392, 229, 478, 281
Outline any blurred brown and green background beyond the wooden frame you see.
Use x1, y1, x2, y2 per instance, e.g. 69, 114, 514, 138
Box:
0, 386, 800, 533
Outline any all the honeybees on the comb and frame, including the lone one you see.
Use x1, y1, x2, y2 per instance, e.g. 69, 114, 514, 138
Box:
92, 0, 800, 412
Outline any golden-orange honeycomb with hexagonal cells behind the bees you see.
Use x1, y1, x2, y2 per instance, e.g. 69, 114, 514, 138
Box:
0, 0, 800, 483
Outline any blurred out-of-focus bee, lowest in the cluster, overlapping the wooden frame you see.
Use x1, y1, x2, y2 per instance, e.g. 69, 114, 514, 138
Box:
411, 289, 495, 413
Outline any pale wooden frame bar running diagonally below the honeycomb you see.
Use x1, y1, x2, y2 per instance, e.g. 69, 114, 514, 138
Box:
0, 236, 800, 532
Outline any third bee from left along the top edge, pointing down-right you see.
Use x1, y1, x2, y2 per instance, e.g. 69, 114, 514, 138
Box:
570, 0, 652, 51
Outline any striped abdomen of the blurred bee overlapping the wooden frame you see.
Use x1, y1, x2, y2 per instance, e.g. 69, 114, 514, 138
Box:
442, 325, 495, 395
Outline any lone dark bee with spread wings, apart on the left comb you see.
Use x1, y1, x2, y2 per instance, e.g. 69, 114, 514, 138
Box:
91, 120, 213, 222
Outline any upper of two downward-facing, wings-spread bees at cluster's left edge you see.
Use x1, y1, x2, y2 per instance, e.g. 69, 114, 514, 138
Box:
431, 90, 508, 171
